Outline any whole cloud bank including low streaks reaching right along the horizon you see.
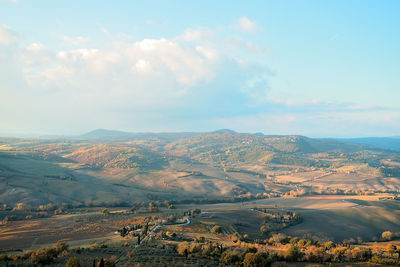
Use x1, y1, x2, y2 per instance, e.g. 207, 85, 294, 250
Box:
0, 17, 400, 136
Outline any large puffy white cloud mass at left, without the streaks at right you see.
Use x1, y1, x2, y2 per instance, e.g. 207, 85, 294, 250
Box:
0, 23, 274, 135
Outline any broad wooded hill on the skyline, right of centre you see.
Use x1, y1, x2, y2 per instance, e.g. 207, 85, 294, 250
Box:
164, 132, 374, 166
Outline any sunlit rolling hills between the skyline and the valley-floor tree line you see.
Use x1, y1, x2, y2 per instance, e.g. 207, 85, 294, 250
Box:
0, 129, 400, 207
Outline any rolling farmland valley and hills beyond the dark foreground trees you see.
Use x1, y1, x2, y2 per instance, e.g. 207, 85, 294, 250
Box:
0, 130, 400, 266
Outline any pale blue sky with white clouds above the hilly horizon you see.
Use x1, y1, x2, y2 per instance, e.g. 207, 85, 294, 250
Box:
0, 0, 400, 137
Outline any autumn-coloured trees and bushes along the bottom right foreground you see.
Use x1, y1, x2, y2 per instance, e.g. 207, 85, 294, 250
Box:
176, 229, 400, 266
